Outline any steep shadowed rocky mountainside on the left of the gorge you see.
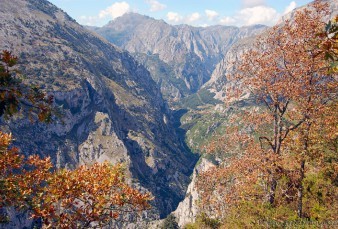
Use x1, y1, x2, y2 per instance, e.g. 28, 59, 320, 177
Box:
0, 0, 196, 218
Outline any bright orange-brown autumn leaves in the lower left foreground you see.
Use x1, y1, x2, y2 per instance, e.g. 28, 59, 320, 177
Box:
0, 132, 150, 228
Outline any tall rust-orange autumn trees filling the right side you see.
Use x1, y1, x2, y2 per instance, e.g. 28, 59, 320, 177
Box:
199, 1, 338, 227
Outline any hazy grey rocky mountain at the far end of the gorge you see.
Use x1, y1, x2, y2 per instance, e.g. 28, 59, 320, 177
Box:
88, 13, 266, 102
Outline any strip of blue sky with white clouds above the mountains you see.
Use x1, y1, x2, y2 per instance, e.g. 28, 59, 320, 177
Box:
49, 0, 311, 26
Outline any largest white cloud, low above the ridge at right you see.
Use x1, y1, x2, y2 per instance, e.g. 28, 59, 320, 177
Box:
220, 6, 281, 26
